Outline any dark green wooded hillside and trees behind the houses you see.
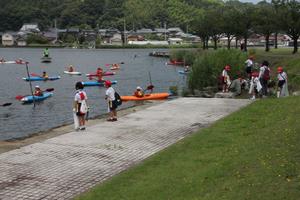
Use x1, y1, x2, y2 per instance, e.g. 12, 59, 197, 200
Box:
0, 0, 300, 53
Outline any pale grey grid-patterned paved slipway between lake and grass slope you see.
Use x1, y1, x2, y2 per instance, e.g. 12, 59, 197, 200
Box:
0, 98, 250, 200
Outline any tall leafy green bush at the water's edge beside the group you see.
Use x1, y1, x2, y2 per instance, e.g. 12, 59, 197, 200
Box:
188, 49, 247, 90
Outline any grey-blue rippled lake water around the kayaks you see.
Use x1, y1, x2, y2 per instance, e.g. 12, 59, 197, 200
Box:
0, 48, 186, 140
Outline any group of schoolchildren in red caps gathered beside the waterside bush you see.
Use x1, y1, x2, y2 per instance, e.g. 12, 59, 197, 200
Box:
221, 56, 289, 99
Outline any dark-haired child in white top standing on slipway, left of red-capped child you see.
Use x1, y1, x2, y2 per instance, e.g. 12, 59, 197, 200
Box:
73, 82, 89, 130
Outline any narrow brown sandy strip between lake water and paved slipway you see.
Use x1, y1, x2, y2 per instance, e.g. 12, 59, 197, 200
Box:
0, 101, 164, 154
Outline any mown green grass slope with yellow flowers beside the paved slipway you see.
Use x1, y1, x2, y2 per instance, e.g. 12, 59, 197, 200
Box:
77, 97, 300, 200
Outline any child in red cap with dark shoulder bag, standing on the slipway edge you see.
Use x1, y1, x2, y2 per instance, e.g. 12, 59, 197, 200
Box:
105, 80, 118, 122
